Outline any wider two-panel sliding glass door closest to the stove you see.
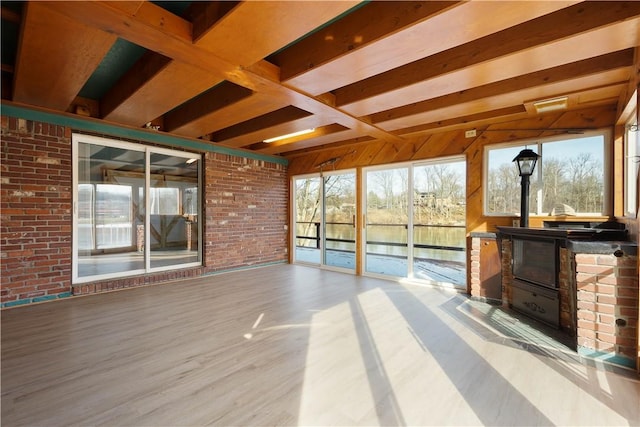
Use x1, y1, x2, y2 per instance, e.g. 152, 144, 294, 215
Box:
363, 159, 466, 287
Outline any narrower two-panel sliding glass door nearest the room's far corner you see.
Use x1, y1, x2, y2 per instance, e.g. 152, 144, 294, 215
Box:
293, 172, 356, 270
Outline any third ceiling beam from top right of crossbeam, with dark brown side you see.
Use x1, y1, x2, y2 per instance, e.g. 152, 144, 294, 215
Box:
333, 2, 640, 111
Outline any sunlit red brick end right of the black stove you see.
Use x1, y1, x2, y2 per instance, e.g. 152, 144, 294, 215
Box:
575, 254, 638, 366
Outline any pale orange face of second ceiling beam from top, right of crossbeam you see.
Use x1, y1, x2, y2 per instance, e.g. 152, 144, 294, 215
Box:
282, 1, 576, 95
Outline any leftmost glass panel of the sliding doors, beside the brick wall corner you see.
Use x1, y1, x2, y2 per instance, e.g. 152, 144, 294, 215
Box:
294, 176, 322, 264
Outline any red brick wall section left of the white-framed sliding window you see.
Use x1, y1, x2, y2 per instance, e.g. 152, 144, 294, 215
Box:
0, 116, 71, 305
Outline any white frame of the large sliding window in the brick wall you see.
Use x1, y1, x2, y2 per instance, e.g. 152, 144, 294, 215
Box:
71, 133, 204, 284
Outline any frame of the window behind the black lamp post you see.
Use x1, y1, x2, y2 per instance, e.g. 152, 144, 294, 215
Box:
482, 128, 613, 218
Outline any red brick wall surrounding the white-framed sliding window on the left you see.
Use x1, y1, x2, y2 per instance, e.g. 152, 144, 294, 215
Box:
0, 116, 288, 307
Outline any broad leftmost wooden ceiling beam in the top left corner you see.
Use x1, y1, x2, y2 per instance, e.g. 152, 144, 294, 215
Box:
13, 2, 117, 111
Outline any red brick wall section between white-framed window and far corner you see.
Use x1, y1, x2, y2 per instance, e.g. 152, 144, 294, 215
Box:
204, 153, 288, 271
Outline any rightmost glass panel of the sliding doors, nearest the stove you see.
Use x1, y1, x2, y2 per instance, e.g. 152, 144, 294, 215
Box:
412, 161, 466, 286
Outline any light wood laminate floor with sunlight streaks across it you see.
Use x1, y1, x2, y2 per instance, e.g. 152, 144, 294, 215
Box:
2, 265, 640, 426
